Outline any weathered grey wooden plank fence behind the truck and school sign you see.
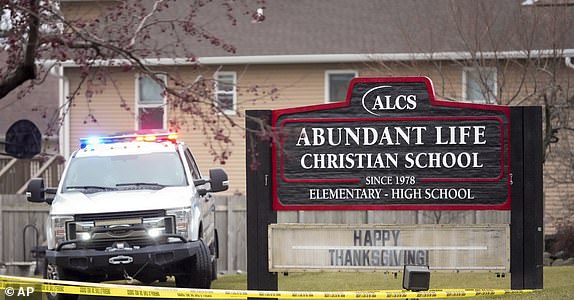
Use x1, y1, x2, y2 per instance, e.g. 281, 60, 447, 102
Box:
0, 195, 510, 273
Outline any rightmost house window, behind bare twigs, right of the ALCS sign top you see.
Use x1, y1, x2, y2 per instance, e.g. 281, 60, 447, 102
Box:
462, 68, 496, 104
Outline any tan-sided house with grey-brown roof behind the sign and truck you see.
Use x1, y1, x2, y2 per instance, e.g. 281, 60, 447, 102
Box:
56, 0, 574, 233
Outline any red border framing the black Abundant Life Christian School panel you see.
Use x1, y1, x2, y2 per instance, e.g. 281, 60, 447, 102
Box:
271, 76, 511, 210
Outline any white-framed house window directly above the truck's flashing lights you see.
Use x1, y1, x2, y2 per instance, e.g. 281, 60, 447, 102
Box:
137, 76, 165, 129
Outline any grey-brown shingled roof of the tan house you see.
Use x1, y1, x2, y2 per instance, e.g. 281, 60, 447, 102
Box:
79, 0, 574, 58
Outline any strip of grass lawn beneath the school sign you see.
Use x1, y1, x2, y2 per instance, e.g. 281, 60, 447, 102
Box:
212, 267, 574, 299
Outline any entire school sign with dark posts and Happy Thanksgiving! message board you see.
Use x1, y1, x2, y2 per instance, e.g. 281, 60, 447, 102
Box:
246, 77, 544, 289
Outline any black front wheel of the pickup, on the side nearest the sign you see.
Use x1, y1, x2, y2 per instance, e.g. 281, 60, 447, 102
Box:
175, 240, 213, 289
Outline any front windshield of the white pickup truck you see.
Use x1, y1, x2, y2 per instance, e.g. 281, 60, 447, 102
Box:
63, 152, 187, 191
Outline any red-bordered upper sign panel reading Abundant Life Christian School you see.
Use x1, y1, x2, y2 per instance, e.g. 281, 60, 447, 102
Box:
272, 77, 512, 210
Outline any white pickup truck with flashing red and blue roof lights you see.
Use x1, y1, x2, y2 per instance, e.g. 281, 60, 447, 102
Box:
27, 133, 229, 299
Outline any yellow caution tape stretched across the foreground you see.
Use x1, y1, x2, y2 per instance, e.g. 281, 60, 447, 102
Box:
0, 276, 533, 299
